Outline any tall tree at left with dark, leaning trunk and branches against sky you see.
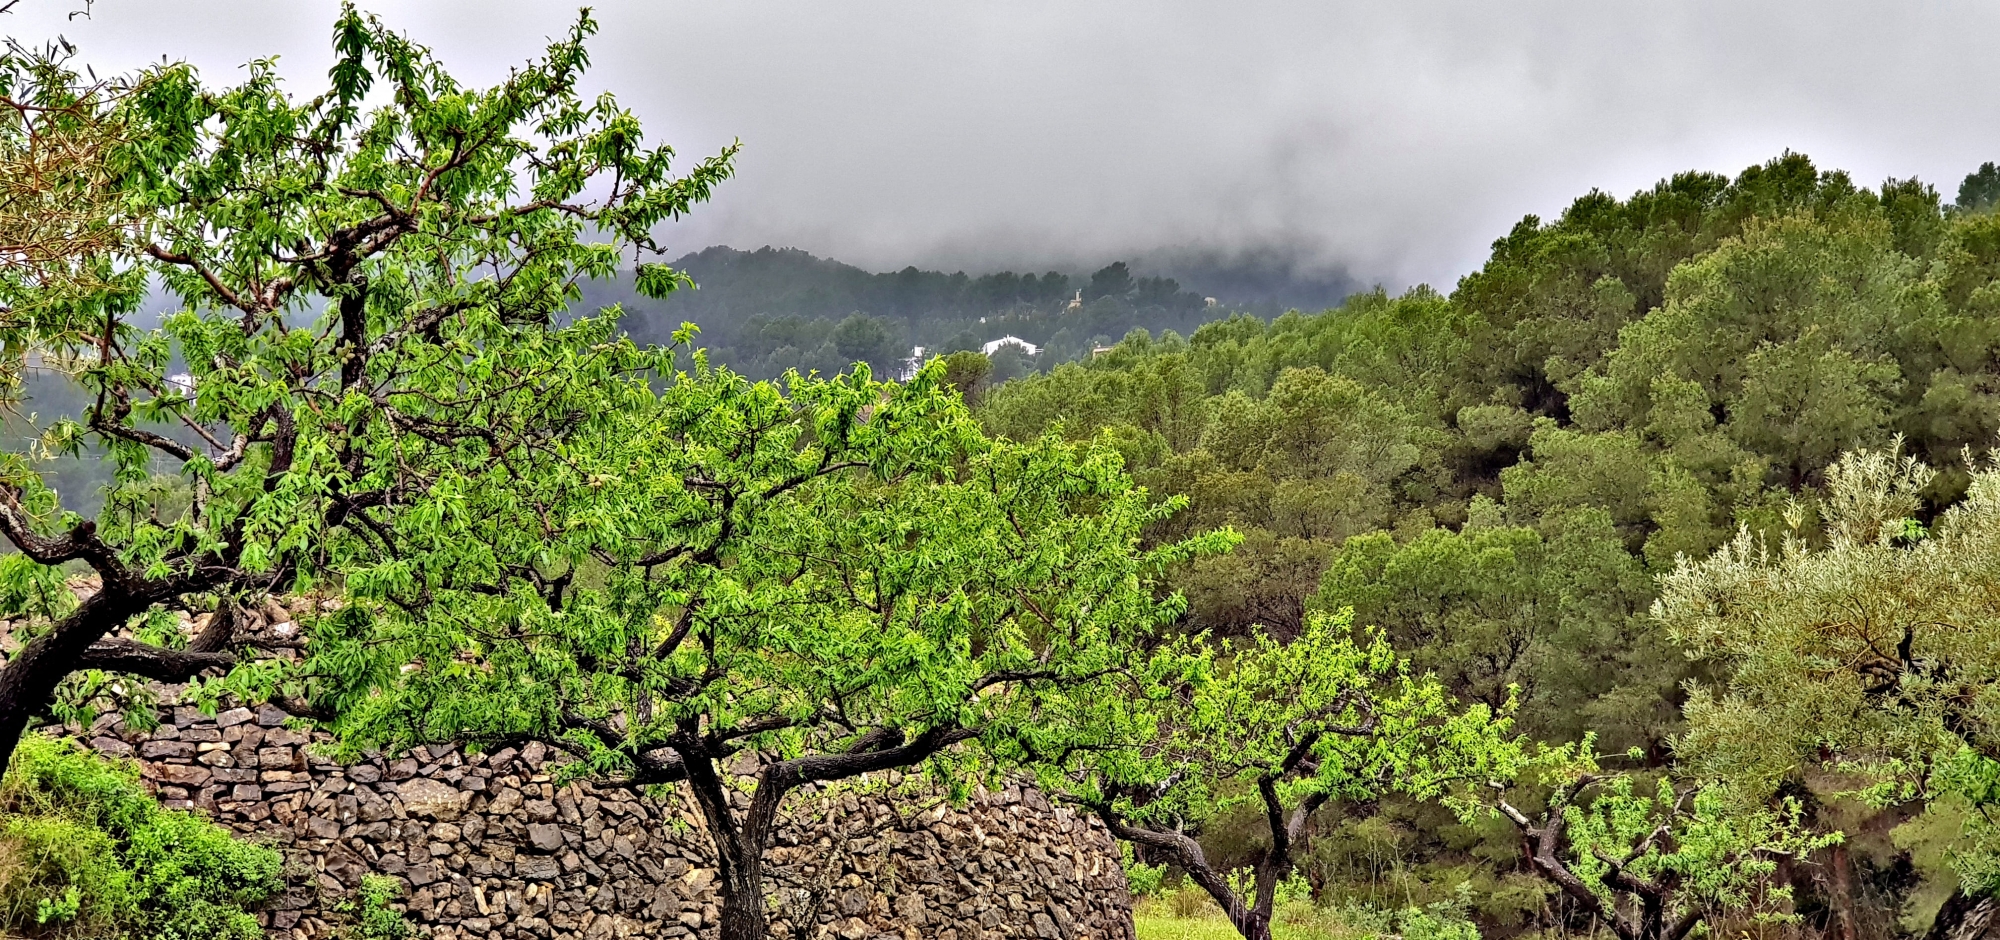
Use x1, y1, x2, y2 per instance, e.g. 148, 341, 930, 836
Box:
0, 8, 734, 764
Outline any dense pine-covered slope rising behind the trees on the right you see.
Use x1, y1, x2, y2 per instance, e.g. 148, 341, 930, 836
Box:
980, 154, 2000, 926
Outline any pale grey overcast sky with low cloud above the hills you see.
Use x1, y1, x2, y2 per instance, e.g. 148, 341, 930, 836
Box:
15, 0, 2000, 286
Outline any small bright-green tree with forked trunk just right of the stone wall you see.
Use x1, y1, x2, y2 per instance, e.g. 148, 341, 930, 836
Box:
1048, 614, 1520, 940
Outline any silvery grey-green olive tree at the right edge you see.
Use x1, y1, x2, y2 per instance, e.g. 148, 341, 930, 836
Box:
1654, 450, 2000, 936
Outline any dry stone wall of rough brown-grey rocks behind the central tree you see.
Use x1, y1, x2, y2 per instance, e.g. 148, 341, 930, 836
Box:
72, 706, 1132, 940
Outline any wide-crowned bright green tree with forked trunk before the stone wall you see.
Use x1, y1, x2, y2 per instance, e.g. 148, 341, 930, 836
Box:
308, 356, 1226, 940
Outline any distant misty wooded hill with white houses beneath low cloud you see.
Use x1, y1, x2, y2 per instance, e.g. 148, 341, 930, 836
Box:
580, 246, 1360, 378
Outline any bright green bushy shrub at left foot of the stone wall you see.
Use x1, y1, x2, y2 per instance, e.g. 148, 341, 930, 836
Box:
0, 734, 284, 940
